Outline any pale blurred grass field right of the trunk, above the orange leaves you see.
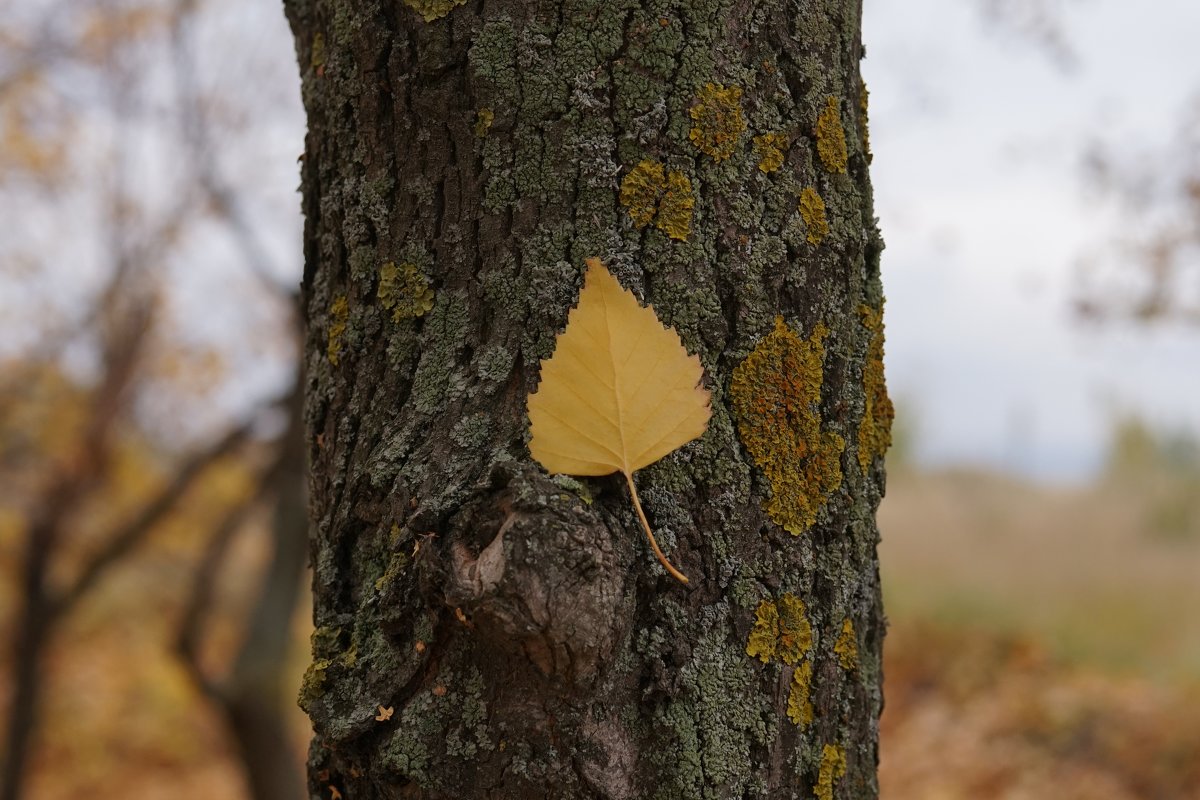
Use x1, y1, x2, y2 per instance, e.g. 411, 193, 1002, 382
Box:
880, 462, 1200, 680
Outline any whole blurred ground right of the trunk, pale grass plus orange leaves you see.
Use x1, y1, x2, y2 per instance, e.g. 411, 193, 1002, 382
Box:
880, 462, 1200, 800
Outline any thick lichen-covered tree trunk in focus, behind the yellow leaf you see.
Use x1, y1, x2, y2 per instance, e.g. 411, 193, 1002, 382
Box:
286, 0, 892, 800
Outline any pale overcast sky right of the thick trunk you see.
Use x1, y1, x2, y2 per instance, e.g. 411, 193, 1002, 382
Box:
863, 0, 1200, 480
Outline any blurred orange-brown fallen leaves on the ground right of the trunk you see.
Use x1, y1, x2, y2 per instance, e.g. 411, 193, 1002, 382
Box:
880, 624, 1200, 800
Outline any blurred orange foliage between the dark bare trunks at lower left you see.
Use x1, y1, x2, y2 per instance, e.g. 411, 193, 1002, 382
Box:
0, 363, 307, 800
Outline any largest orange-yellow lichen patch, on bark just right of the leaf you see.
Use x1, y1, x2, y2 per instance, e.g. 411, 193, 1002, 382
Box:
730, 317, 846, 536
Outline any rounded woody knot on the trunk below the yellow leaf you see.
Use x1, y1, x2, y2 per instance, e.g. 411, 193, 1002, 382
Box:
431, 464, 629, 684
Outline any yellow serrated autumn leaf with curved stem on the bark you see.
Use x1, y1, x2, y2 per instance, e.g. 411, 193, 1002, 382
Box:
528, 258, 712, 583
